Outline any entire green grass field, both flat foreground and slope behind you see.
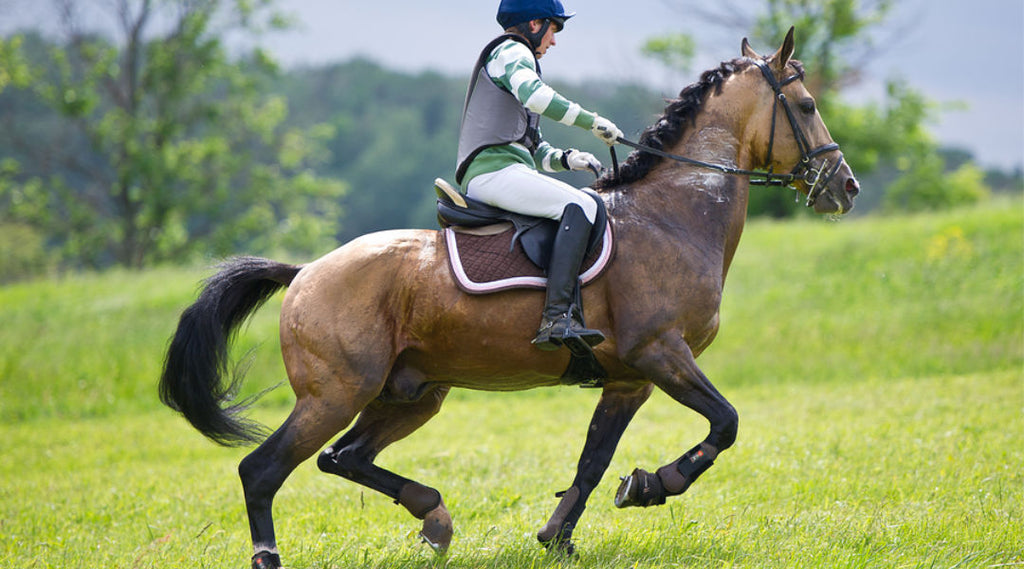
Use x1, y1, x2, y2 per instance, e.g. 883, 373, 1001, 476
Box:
0, 200, 1024, 569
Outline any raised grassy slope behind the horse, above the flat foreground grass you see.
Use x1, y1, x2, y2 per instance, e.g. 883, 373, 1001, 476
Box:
0, 201, 1024, 422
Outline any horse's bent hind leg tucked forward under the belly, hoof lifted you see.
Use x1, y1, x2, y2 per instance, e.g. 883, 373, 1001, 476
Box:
316, 387, 453, 552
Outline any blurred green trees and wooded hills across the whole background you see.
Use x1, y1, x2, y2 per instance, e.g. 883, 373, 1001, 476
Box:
0, 0, 1022, 279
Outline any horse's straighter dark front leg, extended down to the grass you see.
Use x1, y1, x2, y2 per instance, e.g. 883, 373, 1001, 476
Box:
537, 383, 653, 555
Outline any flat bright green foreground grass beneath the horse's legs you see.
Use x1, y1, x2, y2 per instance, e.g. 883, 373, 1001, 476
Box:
0, 371, 1024, 568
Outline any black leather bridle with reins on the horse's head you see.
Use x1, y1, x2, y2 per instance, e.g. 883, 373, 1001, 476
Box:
610, 59, 845, 207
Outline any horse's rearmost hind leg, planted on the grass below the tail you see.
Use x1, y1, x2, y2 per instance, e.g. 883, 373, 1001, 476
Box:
239, 397, 365, 569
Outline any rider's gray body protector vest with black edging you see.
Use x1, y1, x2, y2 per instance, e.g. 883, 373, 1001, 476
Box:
455, 34, 541, 185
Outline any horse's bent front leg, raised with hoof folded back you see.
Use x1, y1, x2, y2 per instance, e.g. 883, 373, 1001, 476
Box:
615, 333, 739, 508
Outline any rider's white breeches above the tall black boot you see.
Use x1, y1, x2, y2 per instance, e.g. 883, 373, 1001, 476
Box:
466, 164, 597, 223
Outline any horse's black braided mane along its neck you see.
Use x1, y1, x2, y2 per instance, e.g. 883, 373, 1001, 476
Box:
592, 57, 752, 190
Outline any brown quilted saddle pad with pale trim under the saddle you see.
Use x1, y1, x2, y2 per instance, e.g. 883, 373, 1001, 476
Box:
444, 223, 612, 295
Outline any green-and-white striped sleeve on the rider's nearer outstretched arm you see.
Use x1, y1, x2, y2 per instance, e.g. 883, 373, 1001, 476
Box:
486, 40, 596, 130
